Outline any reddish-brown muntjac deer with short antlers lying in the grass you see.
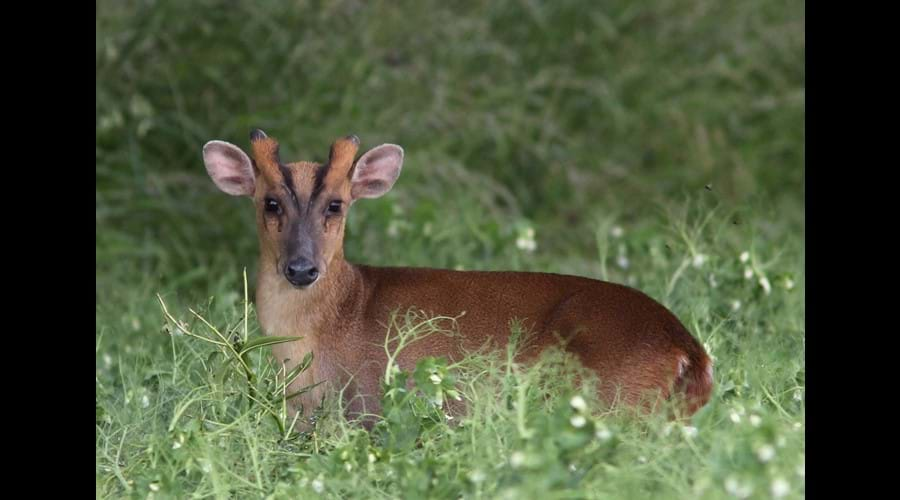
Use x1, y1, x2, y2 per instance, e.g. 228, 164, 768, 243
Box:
203, 130, 713, 426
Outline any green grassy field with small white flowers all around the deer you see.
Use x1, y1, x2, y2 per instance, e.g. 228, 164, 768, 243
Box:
96, 0, 805, 499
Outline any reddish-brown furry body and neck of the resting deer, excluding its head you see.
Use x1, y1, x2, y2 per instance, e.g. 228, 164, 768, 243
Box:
257, 262, 712, 422
